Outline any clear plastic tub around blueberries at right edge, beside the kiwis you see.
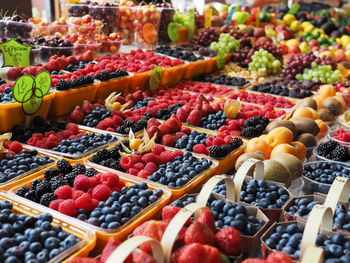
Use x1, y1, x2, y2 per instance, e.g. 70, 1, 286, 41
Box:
302, 161, 350, 194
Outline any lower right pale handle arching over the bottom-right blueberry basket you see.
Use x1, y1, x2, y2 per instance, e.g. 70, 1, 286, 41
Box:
300, 205, 333, 258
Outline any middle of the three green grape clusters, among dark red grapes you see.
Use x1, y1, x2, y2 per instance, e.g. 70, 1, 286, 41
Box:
248, 48, 281, 75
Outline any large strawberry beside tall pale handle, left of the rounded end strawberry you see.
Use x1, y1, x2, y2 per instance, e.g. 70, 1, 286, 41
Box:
185, 221, 215, 248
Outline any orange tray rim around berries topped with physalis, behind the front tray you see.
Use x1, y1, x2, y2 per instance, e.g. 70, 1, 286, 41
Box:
84, 146, 219, 201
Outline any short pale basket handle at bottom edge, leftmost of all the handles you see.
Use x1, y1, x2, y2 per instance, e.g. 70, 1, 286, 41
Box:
106, 236, 164, 263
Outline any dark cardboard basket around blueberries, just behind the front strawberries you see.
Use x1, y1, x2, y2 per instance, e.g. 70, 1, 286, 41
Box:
179, 193, 270, 255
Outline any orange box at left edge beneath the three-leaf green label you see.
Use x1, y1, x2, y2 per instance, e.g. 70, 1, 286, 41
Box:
0, 93, 55, 132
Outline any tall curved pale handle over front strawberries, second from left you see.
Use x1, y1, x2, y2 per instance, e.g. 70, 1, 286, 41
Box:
161, 203, 210, 262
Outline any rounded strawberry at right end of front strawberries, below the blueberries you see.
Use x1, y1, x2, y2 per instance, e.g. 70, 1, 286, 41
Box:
215, 227, 242, 255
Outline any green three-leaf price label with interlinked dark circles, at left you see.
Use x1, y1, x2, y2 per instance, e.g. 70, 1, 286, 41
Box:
12, 70, 51, 115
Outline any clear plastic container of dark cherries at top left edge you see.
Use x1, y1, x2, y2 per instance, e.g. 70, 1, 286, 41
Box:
0, 20, 35, 39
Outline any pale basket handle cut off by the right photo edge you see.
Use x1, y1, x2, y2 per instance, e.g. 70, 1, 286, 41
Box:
324, 176, 350, 213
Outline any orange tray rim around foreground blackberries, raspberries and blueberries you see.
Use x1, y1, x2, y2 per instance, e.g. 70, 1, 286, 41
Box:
9, 164, 171, 253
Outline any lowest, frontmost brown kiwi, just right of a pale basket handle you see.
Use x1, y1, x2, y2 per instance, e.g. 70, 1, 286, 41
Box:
264, 159, 292, 187
